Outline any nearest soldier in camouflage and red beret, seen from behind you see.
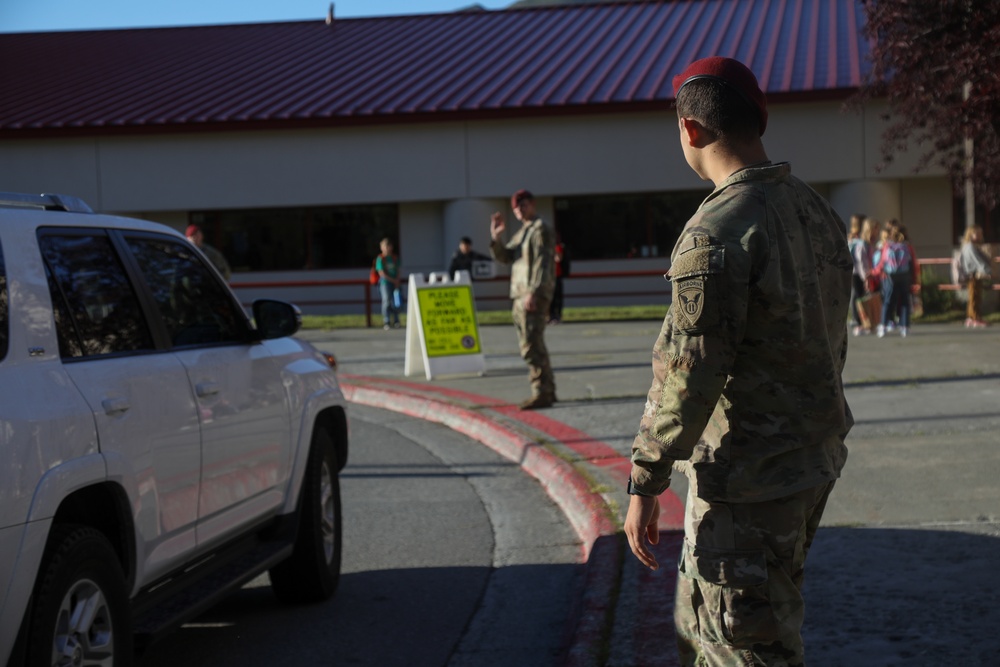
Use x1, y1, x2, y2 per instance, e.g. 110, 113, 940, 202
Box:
625, 58, 853, 667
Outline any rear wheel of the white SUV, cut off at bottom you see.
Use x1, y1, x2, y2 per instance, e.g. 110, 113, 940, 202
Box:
26, 526, 133, 667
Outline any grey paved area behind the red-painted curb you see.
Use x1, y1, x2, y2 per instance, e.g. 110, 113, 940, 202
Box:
310, 322, 1000, 667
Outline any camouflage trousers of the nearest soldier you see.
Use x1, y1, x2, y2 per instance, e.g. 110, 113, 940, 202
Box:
674, 482, 833, 667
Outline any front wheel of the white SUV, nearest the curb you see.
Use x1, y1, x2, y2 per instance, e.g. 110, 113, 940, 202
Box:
270, 429, 341, 603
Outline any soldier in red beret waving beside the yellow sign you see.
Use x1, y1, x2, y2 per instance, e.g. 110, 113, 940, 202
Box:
490, 185, 556, 410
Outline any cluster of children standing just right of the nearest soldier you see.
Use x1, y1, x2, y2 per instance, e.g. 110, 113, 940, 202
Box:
848, 215, 920, 338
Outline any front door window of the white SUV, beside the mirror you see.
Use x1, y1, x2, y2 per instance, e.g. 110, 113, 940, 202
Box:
126, 236, 249, 347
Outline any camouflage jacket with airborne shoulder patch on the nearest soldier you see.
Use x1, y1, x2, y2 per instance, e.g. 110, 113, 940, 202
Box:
632, 163, 854, 502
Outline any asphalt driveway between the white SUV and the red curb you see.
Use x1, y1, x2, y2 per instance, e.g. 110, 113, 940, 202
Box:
138, 406, 583, 667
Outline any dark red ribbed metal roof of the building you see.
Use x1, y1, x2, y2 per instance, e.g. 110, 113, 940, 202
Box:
0, 0, 868, 136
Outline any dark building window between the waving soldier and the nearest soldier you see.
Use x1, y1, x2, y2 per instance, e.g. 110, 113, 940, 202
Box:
555, 191, 708, 259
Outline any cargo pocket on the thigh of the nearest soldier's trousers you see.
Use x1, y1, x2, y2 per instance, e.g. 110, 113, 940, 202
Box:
680, 541, 780, 648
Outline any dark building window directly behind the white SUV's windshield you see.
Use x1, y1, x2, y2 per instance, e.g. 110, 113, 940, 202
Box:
191, 204, 399, 271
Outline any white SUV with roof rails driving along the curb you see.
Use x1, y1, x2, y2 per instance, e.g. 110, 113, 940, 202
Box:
0, 193, 348, 667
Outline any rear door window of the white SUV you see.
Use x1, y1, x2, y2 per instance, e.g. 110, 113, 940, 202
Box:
38, 232, 154, 358
